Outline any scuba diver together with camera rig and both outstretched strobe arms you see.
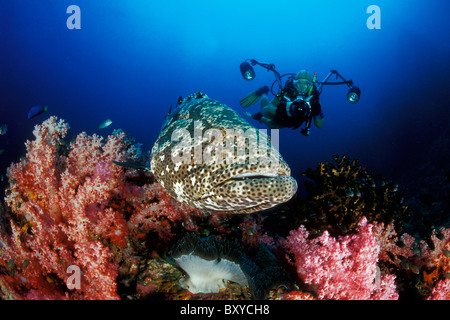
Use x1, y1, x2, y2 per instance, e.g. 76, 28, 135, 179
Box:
240, 59, 361, 136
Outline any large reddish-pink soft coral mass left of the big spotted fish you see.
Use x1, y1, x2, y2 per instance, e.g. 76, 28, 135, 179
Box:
0, 117, 200, 299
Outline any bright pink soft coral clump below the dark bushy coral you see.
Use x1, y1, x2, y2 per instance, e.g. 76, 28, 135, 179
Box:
283, 218, 398, 299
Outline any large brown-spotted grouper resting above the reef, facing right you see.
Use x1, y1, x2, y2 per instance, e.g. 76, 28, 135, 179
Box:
150, 92, 297, 213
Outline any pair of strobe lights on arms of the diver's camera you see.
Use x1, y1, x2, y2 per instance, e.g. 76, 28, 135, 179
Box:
240, 59, 361, 104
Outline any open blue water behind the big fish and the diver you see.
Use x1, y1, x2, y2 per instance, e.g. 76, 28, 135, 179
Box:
0, 0, 450, 200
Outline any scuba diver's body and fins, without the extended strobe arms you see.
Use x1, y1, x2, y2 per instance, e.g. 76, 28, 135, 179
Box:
240, 70, 324, 136
